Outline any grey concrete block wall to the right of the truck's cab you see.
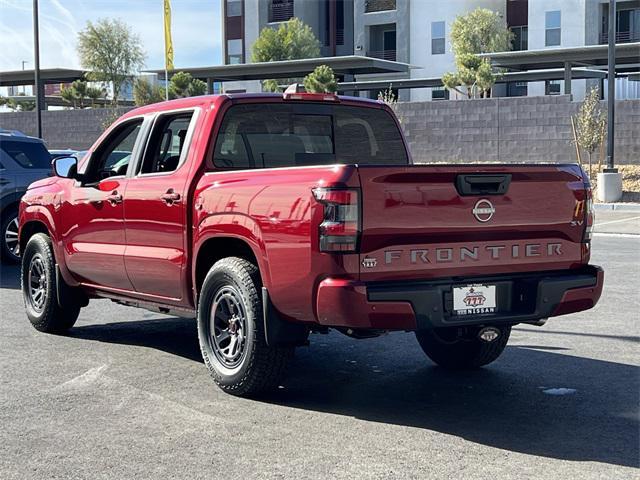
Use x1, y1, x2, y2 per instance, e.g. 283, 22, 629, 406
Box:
396, 95, 640, 164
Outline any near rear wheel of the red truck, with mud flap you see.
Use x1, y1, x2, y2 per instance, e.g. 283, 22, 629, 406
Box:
198, 257, 294, 396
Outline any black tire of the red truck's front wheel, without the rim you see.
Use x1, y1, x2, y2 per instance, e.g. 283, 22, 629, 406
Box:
20, 233, 81, 333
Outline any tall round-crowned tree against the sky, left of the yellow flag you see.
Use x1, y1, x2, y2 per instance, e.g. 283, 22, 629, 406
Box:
78, 19, 145, 106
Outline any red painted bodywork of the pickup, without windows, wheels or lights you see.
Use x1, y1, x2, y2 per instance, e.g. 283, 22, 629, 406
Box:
20, 95, 603, 330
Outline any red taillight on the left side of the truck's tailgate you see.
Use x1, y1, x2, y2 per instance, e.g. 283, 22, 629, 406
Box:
313, 188, 360, 253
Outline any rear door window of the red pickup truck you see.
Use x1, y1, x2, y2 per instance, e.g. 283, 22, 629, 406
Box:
139, 112, 193, 174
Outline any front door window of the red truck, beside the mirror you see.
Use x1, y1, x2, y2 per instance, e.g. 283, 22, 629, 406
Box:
85, 119, 142, 184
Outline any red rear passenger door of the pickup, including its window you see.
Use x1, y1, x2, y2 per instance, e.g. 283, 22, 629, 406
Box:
124, 110, 197, 301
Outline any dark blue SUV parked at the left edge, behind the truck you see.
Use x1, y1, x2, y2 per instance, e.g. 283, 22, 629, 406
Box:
0, 130, 52, 263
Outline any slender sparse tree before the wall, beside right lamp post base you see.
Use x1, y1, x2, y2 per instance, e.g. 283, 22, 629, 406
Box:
573, 87, 607, 178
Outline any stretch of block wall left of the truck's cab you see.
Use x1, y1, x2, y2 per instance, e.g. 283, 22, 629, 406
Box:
0, 108, 130, 150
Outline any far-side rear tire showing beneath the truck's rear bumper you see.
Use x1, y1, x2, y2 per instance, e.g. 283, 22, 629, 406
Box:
416, 326, 511, 369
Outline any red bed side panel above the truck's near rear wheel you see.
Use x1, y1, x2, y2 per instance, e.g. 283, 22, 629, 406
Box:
194, 166, 359, 322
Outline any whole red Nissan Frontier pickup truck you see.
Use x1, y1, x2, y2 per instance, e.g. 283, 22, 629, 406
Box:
19, 93, 603, 395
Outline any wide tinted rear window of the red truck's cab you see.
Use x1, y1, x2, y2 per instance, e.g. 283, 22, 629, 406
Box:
213, 104, 408, 169
